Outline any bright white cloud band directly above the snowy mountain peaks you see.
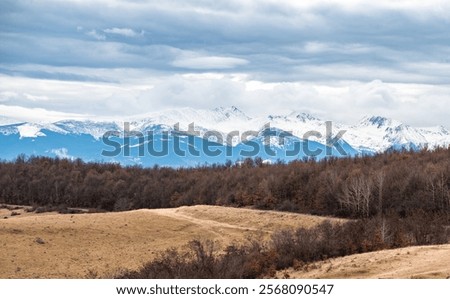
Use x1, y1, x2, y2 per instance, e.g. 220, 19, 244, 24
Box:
0, 72, 450, 128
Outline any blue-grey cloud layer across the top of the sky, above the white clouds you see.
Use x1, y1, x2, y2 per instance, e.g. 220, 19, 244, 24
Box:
0, 0, 450, 82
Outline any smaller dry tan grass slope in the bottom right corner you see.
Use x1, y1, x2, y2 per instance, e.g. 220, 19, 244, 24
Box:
277, 244, 450, 278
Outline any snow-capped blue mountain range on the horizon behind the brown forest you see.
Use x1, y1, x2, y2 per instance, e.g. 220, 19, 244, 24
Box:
0, 107, 450, 166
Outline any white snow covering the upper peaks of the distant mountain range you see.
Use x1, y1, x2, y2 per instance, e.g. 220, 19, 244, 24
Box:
0, 106, 450, 162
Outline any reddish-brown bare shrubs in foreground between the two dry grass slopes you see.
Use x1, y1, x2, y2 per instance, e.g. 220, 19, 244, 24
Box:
118, 215, 449, 279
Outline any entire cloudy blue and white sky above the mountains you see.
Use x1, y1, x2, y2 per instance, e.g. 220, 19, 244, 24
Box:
0, 0, 450, 128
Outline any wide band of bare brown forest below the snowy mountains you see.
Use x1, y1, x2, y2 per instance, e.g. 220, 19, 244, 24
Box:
0, 149, 450, 220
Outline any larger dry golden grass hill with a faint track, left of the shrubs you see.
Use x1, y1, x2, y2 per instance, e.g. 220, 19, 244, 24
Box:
0, 206, 343, 278
